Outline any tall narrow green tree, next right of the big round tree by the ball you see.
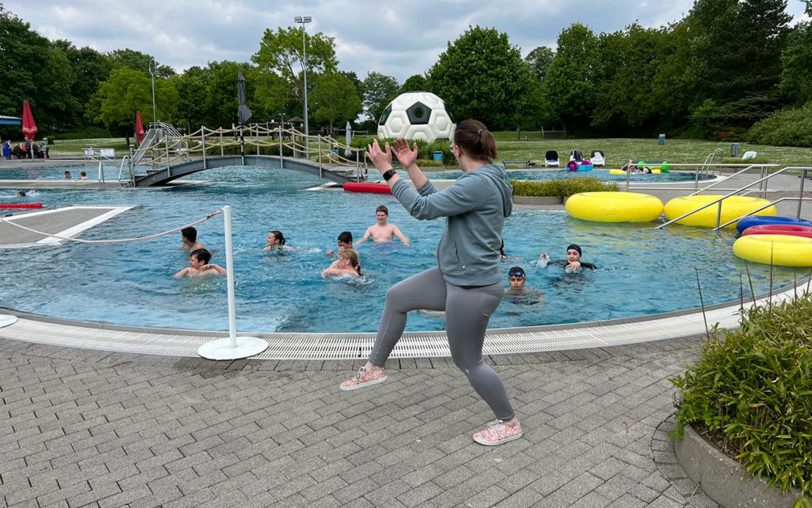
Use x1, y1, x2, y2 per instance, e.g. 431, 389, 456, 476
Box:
542, 23, 599, 131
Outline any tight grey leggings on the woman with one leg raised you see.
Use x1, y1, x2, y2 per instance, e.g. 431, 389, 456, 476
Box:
369, 268, 513, 420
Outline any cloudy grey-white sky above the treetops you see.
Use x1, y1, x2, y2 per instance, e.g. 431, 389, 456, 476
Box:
0, 0, 805, 83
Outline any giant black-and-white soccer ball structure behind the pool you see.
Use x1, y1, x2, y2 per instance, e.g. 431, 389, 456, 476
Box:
378, 92, 456, 143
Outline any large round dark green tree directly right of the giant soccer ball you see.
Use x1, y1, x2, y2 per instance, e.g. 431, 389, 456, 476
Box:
428, 26, 533, 129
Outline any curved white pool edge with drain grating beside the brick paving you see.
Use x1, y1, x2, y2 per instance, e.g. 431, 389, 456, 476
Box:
0, 281, 808, 360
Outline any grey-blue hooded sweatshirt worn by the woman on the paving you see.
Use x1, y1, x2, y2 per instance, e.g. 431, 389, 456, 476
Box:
392, 164, 513, 286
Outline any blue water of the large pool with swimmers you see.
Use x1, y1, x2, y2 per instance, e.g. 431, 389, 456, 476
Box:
0, 167, 793, 332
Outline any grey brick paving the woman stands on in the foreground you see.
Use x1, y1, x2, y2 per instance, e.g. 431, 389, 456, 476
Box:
0, 339, 714, 507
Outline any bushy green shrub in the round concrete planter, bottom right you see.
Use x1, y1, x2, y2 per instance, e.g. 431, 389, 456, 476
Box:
672, 293, 812, 496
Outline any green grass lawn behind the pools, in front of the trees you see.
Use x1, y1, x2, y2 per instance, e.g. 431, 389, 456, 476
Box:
44, 132, 812, 168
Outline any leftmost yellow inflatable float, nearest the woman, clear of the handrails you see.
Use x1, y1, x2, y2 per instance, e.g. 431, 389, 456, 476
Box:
564, 192, 663, 222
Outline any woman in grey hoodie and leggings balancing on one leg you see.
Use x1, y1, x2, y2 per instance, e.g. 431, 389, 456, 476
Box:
340, 120, 522, 446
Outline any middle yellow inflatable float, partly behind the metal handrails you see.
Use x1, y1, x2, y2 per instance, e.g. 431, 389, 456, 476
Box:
665, 195, 777, 228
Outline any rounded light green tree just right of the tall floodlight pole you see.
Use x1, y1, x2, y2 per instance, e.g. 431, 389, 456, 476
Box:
309, 72, 362, 132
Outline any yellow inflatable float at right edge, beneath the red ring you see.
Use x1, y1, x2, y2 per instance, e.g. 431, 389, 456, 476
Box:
733, 235, 812, 267
